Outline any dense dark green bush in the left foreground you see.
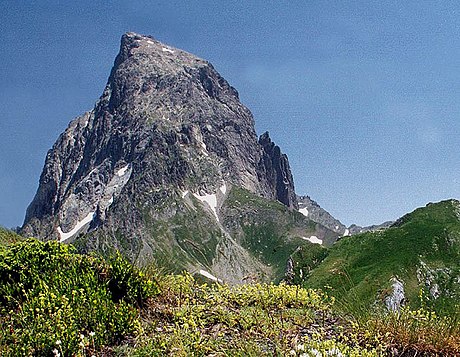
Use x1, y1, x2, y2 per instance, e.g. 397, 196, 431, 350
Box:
0, 239, 159, 356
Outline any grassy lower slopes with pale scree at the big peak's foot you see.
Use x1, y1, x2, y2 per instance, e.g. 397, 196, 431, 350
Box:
72, 186, 337, 282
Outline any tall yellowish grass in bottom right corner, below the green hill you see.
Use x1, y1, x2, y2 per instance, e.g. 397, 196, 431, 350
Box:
334, 284, 460, 356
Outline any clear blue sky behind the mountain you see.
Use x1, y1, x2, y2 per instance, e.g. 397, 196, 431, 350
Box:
0, 0, 460, 227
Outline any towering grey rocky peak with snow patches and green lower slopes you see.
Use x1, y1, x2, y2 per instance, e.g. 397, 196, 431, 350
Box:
22, 33, 338, 283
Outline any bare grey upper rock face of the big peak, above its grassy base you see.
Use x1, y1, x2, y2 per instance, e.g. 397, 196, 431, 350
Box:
24, 33, 295, 238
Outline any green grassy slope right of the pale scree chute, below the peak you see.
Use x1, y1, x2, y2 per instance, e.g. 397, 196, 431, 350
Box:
222, 187, 337, 281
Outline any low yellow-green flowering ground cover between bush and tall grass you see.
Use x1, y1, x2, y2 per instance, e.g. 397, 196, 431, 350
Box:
114, 273, 378, 356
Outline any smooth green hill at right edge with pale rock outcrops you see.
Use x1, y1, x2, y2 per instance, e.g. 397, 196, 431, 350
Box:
302, 200, 460, 309
